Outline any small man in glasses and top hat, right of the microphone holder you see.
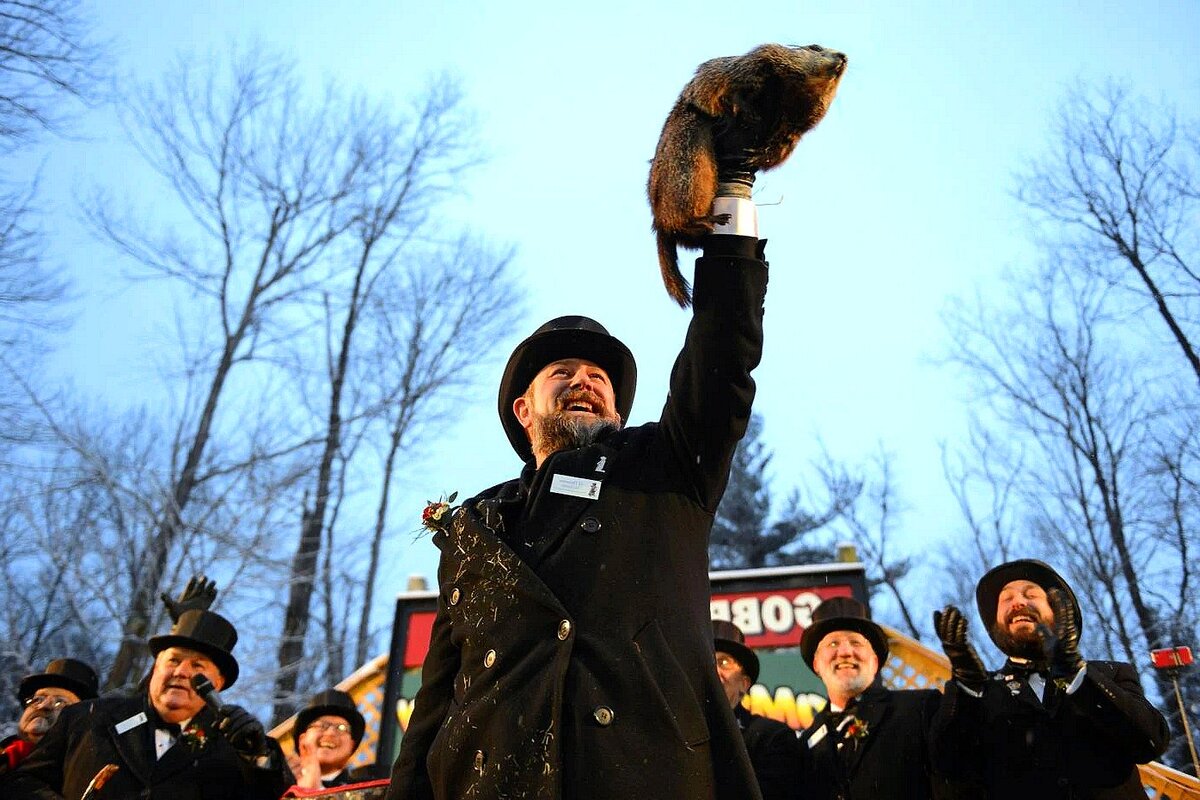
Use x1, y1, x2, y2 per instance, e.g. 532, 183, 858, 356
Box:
292, 688, 367, 789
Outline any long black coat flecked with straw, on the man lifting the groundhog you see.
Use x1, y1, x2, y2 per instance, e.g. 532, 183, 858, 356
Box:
389, 236, 767, 800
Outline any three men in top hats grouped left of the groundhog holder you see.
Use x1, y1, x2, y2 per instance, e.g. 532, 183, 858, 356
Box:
0, 577, 366, 800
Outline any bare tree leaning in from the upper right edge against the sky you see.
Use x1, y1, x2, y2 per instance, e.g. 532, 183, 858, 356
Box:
1018, 83, 1200, 379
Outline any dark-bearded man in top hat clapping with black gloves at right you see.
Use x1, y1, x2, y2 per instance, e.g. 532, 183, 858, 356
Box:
934, 559, 1170, 800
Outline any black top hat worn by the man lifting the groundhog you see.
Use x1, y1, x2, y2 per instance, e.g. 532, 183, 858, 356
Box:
497, 317, 637, 461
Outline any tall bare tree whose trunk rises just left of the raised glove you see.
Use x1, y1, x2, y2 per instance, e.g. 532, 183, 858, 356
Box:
85, 53, 393, 687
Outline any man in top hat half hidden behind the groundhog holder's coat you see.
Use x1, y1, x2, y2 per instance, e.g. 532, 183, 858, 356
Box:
713, 619, 800, 800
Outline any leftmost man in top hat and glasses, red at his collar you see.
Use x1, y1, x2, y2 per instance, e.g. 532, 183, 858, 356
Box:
0, 658, 100, 772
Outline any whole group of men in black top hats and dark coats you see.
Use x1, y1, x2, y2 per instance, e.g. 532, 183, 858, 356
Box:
0, 73, 1169, 800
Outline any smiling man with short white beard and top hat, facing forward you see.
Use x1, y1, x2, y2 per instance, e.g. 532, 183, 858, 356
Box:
799, 597, 950, 800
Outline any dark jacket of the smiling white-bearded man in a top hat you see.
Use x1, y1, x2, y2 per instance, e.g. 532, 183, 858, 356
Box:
800, 681, 948, 800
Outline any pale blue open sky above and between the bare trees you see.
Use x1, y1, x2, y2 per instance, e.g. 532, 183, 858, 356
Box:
16, 0, 1200, 633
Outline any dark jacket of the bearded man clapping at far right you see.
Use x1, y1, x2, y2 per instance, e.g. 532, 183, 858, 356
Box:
932, 661, 1170, 800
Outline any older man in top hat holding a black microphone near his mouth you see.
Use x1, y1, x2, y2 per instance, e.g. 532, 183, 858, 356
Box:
5, 610, 292, 800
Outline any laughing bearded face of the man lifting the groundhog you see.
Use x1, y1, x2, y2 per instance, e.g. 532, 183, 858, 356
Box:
512, 359, 622, 467
